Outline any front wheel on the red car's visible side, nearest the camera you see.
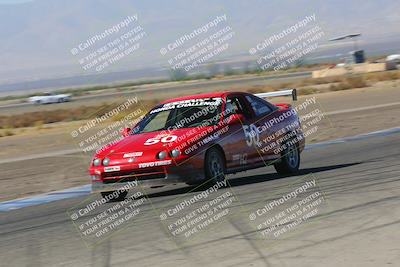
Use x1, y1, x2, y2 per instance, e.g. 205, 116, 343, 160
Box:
204, 147, 226, 183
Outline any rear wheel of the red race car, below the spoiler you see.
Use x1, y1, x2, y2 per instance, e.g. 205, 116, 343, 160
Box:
274, 145, 300, 175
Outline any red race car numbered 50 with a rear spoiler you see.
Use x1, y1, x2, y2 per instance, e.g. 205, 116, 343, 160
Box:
89, 89, 305, 199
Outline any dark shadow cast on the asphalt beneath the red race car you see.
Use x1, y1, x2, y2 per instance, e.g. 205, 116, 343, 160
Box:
142, 162, 362, 198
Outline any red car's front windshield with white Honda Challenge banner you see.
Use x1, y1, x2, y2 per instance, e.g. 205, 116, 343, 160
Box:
131, 98, 222, 134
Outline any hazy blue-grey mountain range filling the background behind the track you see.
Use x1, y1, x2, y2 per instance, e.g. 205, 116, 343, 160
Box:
0, 0, 400, 90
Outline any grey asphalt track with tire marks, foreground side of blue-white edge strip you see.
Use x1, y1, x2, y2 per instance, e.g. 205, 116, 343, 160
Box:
0, 132, 400, 266
